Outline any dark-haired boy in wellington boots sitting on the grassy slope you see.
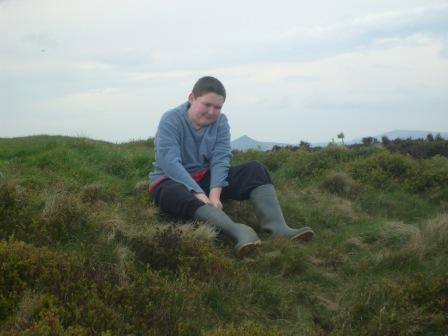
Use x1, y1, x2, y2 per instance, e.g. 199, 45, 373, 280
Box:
149, 76, 314, 257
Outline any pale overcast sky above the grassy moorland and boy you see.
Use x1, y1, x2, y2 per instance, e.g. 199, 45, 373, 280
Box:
0, 0, 448, 143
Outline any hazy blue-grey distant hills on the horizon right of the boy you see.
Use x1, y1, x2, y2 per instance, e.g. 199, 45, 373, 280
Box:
231, 130, 448, 151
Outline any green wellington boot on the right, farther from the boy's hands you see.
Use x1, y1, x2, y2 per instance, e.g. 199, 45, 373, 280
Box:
250, 184, 314, 241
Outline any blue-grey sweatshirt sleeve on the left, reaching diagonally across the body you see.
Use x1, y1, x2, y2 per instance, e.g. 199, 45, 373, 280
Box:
156, 114, 204, 192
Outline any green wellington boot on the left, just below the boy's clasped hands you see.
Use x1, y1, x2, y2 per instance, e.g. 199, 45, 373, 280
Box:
195, 204, 261, 257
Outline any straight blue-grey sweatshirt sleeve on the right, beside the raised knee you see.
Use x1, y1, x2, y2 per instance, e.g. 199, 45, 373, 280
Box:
210, 114, 232, 189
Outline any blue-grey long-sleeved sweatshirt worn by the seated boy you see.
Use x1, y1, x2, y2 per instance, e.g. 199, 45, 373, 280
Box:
149, 102, 232, 192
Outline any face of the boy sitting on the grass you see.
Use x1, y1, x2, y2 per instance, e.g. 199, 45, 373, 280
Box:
188, 92, 225, 129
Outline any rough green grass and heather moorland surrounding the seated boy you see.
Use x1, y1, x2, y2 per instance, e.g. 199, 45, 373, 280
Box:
0, 136, 448, 336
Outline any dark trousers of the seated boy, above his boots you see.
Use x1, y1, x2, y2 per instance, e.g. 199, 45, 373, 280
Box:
151, 161, 272, 220
